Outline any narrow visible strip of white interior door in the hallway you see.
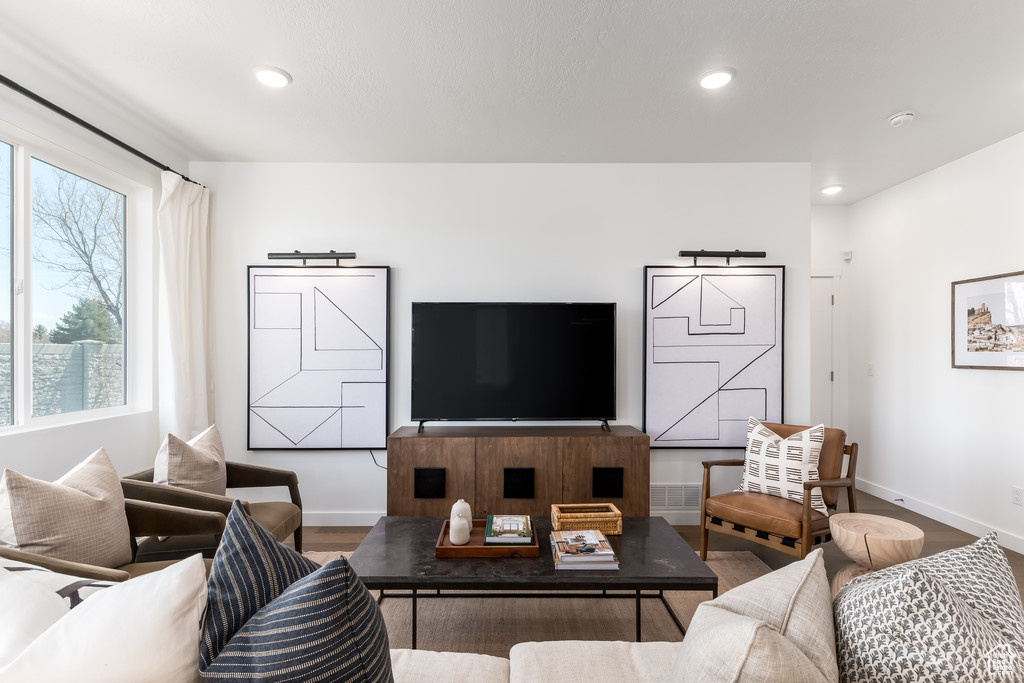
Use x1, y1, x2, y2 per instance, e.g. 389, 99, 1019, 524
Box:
811, 278, 836, 427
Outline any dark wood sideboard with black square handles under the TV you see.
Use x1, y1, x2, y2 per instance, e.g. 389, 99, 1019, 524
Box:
387, 425, 650, 517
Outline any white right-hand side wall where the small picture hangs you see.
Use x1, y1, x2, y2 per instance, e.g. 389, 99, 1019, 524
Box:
849, 134, 1024, 552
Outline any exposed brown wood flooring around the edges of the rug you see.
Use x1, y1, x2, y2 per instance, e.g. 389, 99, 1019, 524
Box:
302, 492, 1024, 590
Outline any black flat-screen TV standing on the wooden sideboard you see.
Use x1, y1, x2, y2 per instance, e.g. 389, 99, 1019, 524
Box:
412, 302, 615, 422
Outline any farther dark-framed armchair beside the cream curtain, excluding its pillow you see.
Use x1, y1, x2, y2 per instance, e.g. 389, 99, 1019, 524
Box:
121, 462, 302, 560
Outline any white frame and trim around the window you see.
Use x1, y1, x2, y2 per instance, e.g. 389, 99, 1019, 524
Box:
0, 122, 155, 435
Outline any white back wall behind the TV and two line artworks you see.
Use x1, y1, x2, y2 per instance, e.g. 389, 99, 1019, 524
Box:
189, 163, 810, 524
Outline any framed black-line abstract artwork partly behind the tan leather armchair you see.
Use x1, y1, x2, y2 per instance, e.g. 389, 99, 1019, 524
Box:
644, 266, 784, 449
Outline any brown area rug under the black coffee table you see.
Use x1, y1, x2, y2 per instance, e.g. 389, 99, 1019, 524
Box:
303, 551, 771, 657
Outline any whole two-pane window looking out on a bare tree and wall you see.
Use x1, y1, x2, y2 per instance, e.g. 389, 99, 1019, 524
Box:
0, 134, 128, 427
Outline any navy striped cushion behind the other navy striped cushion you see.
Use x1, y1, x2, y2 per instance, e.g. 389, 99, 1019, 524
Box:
200, 501, 319, 667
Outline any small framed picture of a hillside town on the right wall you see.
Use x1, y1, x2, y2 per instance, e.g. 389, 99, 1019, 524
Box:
951, 270, 1024, 370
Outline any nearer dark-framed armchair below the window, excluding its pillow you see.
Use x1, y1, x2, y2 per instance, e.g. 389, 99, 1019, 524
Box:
0, 500, 226, 582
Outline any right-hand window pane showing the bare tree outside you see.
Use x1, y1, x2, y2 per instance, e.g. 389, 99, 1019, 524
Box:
32, 159, 126, 416
